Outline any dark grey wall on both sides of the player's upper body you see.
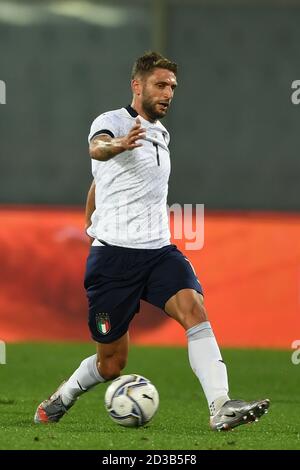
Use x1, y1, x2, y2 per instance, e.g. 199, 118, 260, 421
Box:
0, 1, 300, 209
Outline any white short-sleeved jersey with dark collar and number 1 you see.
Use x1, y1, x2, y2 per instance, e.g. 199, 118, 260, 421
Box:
88, 106, 170, 249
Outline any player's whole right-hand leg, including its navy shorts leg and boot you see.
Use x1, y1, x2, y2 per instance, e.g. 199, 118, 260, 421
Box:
144, 245, 269, 430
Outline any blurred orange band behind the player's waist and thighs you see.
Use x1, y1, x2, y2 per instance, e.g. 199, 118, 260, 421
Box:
0, 207, 300, 349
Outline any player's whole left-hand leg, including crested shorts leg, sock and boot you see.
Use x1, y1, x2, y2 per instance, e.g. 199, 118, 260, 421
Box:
34, 246, 144, 423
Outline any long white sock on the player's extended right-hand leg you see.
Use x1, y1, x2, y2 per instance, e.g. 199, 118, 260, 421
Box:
186, 321, 229, 415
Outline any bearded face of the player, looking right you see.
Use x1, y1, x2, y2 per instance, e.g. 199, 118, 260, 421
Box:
141, 68, 177, 121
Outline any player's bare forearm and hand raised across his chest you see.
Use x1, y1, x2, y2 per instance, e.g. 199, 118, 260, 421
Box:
89, 118, 146, 162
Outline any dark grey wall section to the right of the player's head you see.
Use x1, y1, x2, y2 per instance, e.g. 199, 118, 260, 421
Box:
170, 6, 300, 209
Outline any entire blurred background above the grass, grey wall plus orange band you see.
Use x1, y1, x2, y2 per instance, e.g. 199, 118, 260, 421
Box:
0, 0, 300, 349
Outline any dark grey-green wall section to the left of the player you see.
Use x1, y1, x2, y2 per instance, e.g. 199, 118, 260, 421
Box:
0, 2, 150, 204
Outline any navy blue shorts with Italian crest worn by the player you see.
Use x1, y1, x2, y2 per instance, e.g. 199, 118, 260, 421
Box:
84, 245, 202, 343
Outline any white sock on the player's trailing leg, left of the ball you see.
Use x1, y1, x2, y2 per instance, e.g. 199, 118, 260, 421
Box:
60, 354, 105, 406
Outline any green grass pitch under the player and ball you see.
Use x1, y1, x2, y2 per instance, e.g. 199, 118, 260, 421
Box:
0, 343, 300, 450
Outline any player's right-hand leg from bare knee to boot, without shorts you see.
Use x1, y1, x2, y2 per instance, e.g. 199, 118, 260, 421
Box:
165, 289, 270, 431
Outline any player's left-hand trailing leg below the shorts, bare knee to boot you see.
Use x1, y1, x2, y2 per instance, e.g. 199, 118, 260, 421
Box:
34, 332, 128, 424
